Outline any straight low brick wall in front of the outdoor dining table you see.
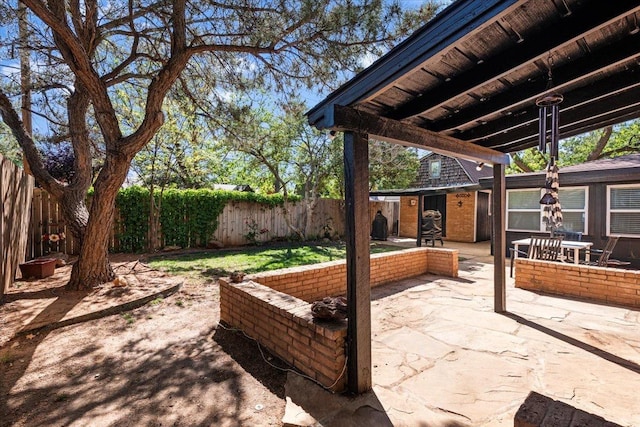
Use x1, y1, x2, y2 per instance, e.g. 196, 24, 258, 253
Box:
515, 258, 640, 307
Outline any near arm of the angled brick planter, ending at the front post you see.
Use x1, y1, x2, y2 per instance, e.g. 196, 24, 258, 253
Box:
219, 279, 347, 392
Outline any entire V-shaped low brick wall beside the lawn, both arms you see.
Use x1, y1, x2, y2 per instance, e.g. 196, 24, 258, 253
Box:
219, 248, 458, 391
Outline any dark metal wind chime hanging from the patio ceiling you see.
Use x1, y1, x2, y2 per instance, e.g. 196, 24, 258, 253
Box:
536, 67, 564, 205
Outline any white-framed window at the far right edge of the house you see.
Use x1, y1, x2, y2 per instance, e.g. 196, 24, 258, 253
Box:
607, 185, 640, 237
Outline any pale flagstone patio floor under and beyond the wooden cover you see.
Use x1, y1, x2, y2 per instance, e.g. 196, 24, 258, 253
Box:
283, 246, 640, 427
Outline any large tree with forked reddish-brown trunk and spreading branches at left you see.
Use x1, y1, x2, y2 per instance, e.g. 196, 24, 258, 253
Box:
0, 0, 438, 289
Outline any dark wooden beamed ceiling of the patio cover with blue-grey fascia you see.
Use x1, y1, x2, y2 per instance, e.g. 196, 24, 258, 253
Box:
308, 0, 640, 159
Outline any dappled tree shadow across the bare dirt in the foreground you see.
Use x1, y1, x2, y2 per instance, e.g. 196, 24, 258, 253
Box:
0, 328, 285, 426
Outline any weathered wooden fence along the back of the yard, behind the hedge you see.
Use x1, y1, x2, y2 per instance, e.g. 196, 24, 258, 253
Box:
27, 188, 393, 259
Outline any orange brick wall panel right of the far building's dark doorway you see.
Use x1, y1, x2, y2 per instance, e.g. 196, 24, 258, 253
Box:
447, 191, 477, 243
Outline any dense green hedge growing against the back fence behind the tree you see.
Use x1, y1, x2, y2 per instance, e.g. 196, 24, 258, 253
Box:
116, 187, 299, 252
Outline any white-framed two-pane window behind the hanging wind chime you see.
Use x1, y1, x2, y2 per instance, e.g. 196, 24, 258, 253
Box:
507, 187, 588, 233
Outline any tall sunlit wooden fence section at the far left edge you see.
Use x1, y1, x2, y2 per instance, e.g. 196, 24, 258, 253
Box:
0, 155, 34, 301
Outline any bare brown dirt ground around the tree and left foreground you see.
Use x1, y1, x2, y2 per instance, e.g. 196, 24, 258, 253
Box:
0, 258, 286, 427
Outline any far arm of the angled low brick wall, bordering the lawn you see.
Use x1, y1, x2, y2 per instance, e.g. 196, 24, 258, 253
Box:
247, 247, 458, 302
